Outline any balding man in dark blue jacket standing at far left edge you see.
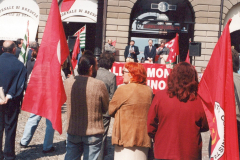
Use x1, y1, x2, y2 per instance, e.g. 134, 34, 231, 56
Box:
0, 41, 27, 159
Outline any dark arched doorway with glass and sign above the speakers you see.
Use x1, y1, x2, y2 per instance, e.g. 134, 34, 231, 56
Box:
129, 0, 195, 61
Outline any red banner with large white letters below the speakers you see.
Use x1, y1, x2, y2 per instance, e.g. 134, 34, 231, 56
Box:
111, 62, 171, 94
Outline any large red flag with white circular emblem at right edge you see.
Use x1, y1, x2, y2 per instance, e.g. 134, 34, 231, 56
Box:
199, 20, 239, 160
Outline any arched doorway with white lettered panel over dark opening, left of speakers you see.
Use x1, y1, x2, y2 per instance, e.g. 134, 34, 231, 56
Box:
59, 0, 98, 52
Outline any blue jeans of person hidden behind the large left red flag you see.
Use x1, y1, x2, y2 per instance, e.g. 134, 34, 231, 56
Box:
21, 113, 54, 151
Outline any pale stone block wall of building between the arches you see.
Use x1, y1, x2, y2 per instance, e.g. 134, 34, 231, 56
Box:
36, 0, 240, 71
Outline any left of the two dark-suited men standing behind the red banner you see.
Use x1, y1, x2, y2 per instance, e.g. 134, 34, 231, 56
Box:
124, 40, 139, 62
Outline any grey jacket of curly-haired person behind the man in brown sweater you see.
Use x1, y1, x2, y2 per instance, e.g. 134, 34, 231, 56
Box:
96, 67, 117, 117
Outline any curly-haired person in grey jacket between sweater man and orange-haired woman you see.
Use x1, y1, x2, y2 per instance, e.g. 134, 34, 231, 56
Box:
96, 53, 117, 160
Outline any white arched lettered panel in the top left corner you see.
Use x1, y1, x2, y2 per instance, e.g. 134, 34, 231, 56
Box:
0, 0, 39, 41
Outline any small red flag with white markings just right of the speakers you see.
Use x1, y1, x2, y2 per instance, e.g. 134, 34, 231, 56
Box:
166, 33, 179, 63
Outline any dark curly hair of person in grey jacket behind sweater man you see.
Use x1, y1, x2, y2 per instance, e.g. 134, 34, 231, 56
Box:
98, 52, 115, 70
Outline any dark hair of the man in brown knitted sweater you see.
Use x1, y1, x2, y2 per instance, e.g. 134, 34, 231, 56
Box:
78, 54, 96, 75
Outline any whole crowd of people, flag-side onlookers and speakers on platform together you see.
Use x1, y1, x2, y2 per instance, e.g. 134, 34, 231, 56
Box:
0, 40, 240, 160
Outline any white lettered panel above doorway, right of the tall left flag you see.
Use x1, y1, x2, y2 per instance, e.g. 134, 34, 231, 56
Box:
59, 0, 98, 23
